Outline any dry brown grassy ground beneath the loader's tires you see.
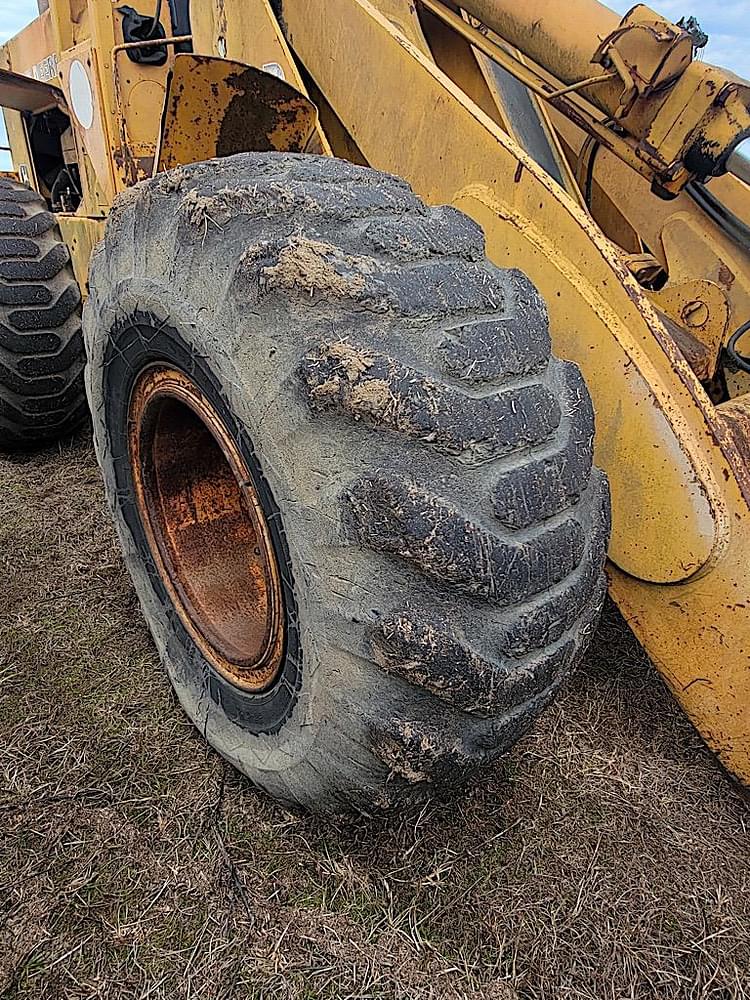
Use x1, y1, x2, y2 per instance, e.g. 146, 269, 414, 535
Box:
0, 435, 750, 1000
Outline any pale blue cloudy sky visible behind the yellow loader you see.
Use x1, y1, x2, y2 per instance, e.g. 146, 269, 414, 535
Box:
0, 0, 750, 170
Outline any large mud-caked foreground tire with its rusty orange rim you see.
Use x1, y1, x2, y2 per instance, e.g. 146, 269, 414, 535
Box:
84, 154, 609, 810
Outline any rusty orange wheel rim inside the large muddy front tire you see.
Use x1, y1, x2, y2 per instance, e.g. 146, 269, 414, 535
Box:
128, 367, 285, 691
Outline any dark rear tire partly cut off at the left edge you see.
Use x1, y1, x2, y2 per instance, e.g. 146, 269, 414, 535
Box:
0, 179, 87, 451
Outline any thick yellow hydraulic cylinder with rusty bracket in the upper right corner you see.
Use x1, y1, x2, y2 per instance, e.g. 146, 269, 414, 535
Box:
422, 0, 750, 198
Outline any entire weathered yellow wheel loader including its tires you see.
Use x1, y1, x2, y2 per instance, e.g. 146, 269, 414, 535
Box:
0, 0, 750, 810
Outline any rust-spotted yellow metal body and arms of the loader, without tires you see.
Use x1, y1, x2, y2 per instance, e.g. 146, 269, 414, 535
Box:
0, 0, 750, 784
